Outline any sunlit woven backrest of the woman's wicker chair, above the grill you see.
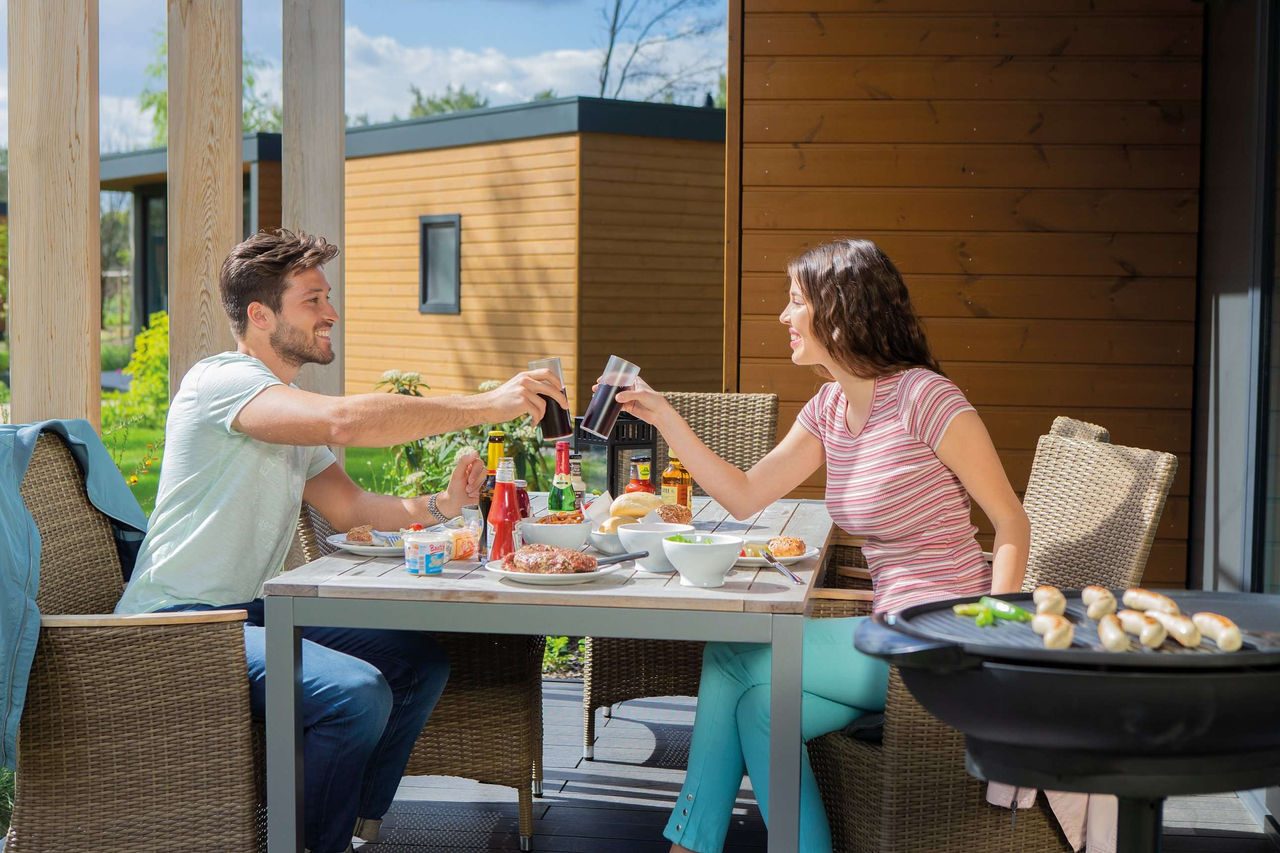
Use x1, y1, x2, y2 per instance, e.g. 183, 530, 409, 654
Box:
1023, 435, 1178, 589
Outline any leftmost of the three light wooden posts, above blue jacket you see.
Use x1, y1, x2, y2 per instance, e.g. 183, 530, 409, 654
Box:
9, 0, 102, 425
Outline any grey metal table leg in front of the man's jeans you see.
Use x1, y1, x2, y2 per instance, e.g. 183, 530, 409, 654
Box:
265, 596, 302, 853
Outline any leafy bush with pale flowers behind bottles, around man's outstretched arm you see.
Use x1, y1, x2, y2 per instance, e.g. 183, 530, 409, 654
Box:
375, 370, 553, 497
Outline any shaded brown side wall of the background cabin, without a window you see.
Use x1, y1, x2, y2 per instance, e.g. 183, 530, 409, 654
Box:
577, 133, 724, 400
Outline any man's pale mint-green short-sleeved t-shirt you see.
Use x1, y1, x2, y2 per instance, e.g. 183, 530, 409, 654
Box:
115, 352, 337, 613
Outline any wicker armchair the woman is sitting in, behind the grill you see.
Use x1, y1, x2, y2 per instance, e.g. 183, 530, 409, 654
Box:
808, 435, 1178, 853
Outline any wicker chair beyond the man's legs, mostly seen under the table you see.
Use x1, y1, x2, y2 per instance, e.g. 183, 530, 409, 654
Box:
297, 505, 545, 849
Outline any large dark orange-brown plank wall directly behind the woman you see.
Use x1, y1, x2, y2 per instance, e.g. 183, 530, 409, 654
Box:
726, 0, 1202, 584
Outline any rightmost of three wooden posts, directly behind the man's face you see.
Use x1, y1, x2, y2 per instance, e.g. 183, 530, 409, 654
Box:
282, 0, 347, 394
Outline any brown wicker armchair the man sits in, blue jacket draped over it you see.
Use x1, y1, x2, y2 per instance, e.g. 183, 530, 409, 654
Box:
5, 434, 266, 853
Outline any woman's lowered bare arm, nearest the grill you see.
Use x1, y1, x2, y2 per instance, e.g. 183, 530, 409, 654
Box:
938, 411, 1032, 593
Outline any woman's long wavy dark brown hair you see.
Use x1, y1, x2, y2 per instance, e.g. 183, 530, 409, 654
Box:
787, 240, 942, 379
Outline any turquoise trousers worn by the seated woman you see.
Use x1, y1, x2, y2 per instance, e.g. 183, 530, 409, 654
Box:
663, 617, 888, 853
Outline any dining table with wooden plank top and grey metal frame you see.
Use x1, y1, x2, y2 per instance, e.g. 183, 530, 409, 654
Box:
264, 494, 832, 853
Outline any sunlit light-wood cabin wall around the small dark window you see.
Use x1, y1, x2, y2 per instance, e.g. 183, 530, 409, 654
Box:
343, 136, 579, 402
